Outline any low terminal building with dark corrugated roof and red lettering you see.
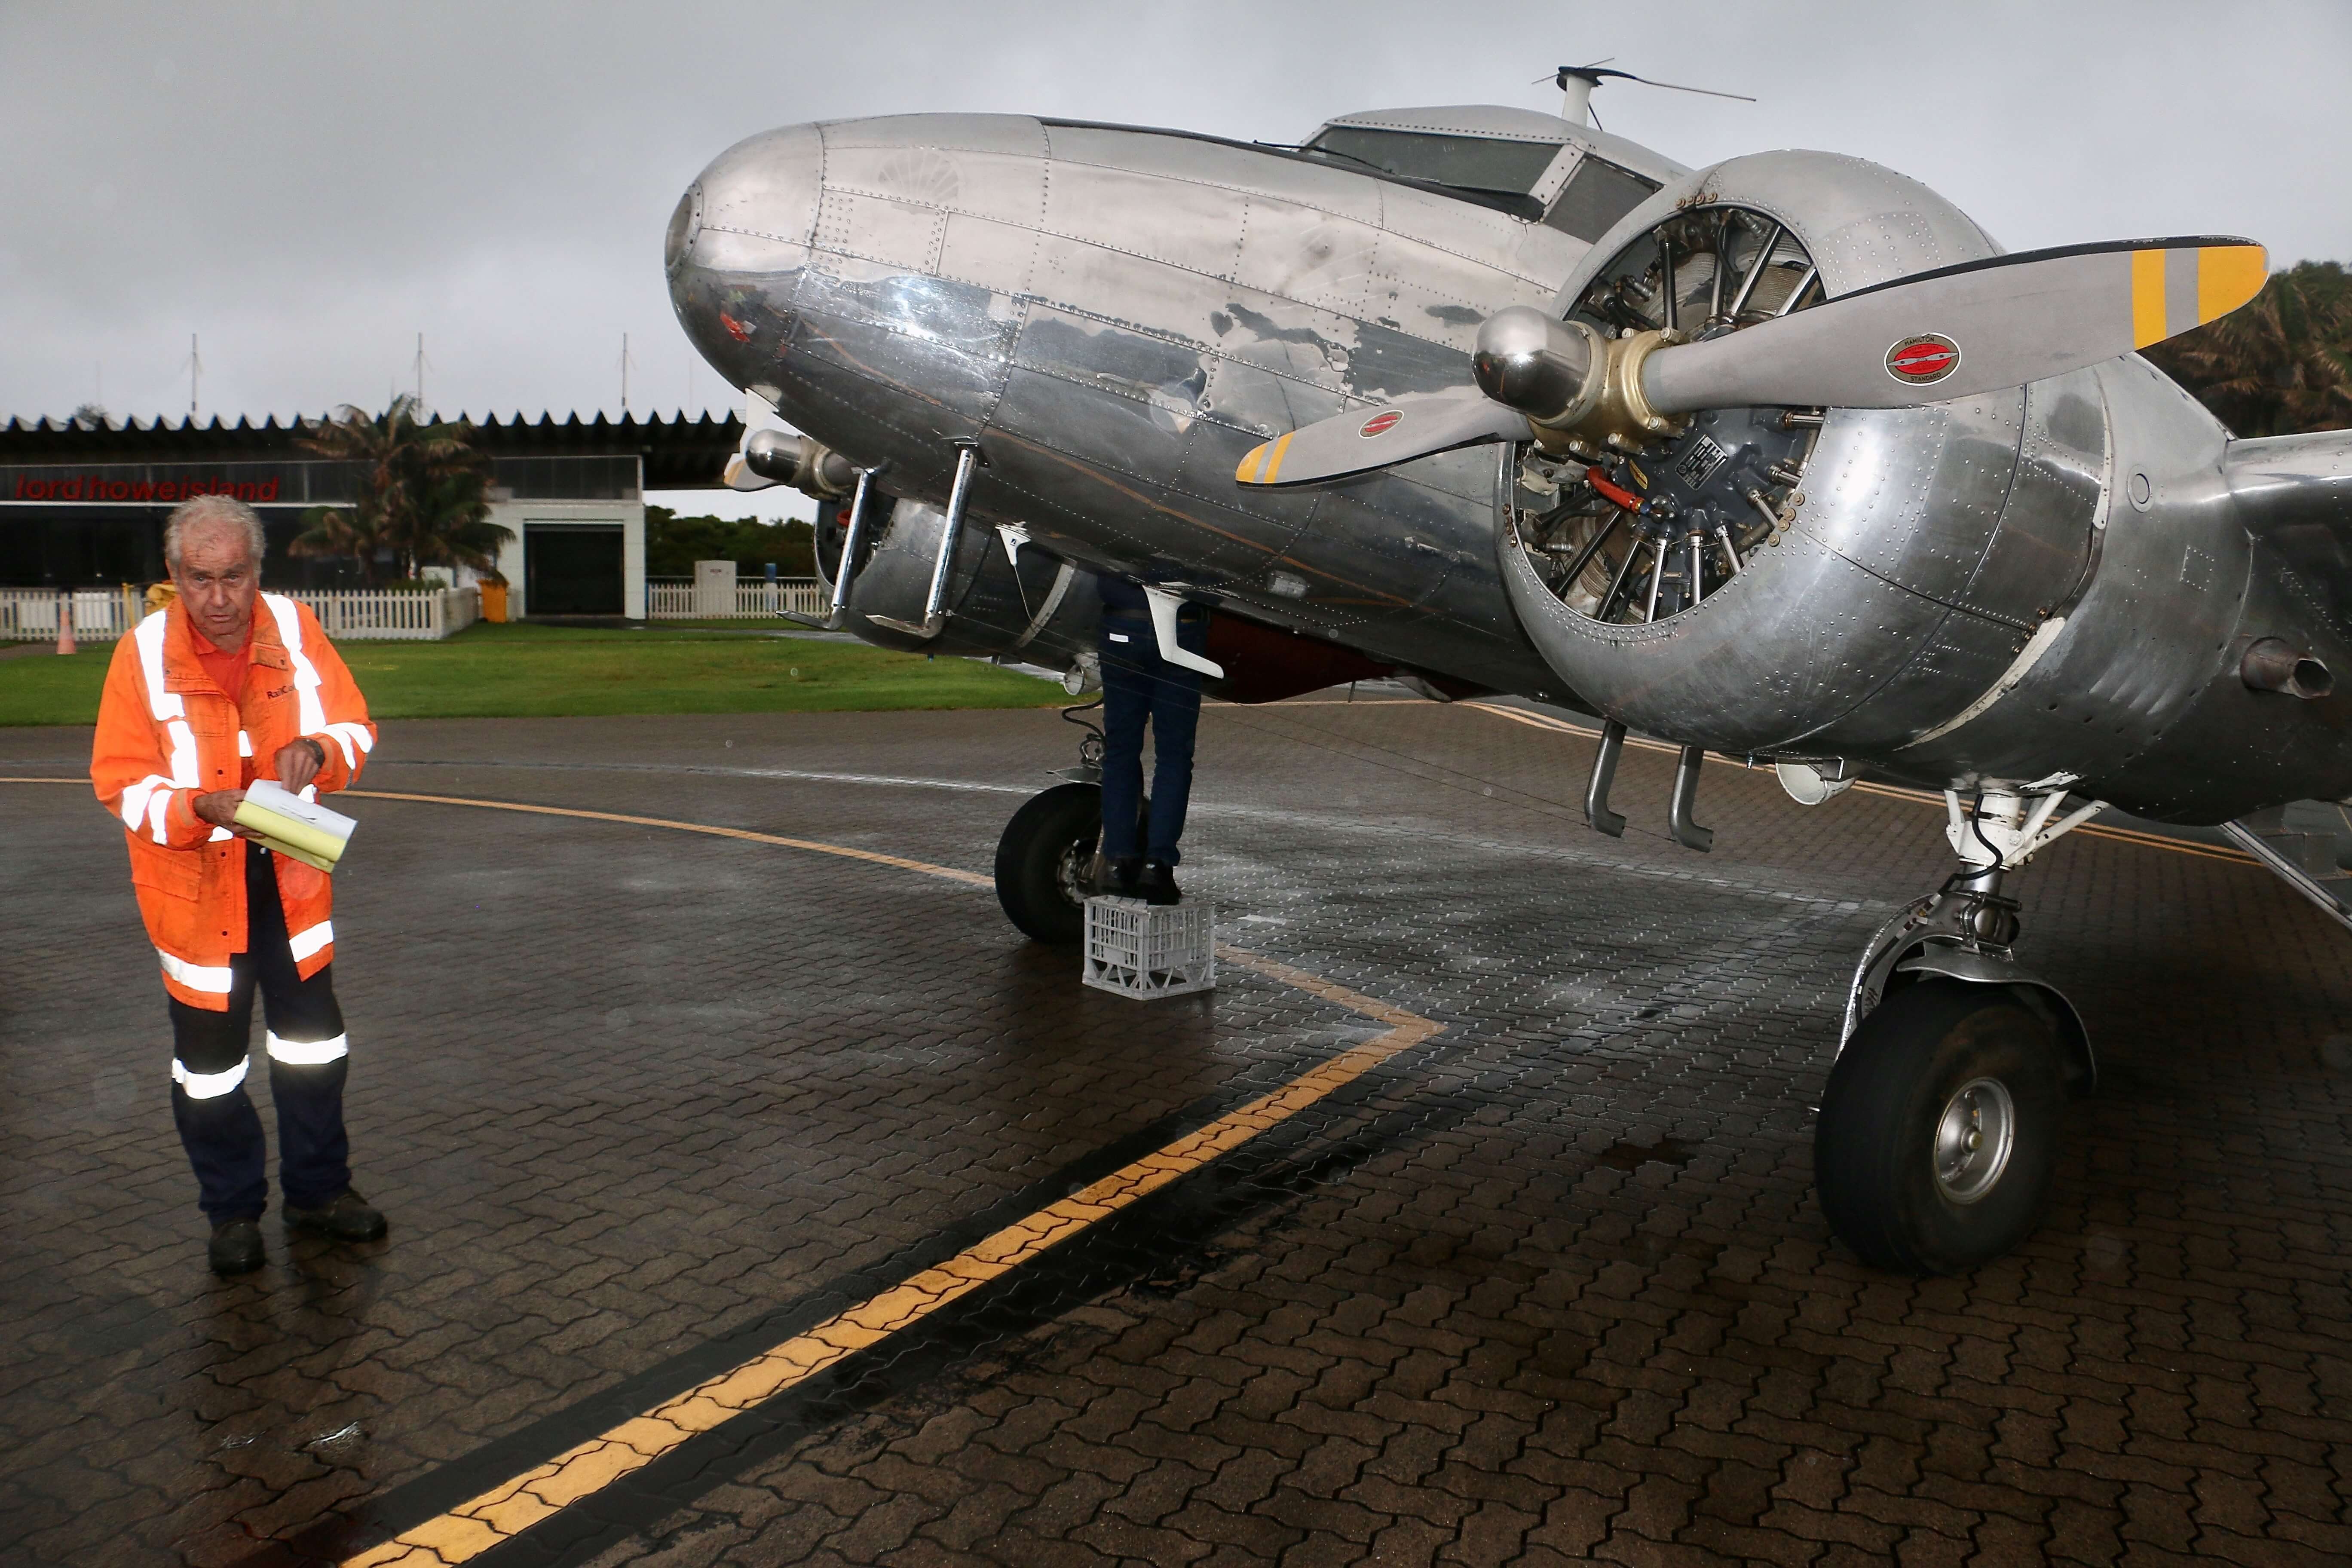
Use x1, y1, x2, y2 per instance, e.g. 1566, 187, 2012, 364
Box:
0, 414, 743, 621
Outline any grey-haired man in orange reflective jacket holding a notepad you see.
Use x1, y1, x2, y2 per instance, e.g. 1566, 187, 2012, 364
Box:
89, 496, 383, 1274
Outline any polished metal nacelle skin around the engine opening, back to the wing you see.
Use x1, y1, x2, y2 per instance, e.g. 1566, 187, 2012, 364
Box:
1496, 153, 2352, 823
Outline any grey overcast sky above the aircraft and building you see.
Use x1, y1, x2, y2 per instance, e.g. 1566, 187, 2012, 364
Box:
0, 0, 2352, 522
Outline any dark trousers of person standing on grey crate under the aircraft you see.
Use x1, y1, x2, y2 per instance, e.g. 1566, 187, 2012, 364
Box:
1101, 613, 1209, 865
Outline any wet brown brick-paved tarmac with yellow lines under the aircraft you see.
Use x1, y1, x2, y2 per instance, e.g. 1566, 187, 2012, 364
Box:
0, 693, 2352, 1566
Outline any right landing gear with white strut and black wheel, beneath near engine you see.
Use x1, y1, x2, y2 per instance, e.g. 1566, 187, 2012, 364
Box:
1813, 790, 2100, 1274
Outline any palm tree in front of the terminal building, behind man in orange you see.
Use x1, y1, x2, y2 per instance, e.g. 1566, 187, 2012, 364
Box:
289, 392, 515, 585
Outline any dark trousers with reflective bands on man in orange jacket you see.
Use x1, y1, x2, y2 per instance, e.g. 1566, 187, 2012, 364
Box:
172, 844, 350, 1225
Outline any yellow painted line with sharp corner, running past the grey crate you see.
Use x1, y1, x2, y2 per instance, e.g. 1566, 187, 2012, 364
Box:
202, 778, 1444, 1568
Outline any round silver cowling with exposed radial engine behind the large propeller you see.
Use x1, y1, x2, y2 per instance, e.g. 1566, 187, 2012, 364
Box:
1496, 153, 2340, 821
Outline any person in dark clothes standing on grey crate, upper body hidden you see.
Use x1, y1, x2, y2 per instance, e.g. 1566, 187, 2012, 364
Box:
1096, 576, 1209, 905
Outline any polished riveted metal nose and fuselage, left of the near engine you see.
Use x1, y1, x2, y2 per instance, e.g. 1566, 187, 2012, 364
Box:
671, 110, 1679, 701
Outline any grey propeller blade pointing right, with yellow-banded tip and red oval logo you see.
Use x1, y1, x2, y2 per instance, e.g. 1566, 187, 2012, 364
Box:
1642, 240, 2269, 414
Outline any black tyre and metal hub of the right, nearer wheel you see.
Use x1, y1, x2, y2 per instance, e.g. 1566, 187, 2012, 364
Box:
1813, 980, 2063, 1274
